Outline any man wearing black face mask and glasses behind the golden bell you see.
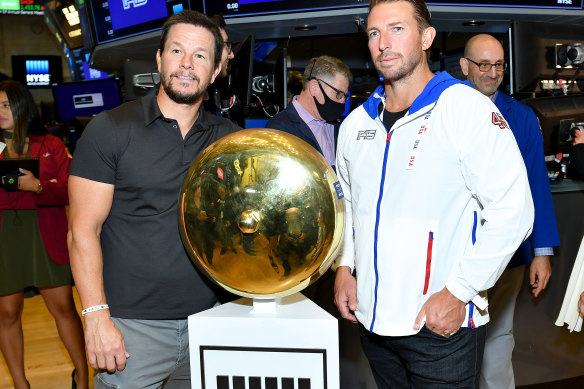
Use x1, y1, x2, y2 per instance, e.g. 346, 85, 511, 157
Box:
266, 56, 353, 167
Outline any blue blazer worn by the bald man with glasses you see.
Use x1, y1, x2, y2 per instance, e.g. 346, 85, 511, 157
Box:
495, 91, 560, 269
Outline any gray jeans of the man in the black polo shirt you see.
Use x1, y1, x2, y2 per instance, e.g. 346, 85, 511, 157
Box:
94, 318, 191, 389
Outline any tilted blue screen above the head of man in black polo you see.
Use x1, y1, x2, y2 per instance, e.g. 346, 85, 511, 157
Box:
89, 0, 202, 44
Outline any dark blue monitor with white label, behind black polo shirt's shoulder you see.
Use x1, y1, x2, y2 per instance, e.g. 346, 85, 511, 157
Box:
53, 78, 122, 122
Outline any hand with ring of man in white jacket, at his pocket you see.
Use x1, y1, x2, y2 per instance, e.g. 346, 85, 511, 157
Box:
414, 288, 466, 337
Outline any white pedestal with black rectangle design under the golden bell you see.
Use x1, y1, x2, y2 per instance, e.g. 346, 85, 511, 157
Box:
189, 293, 339, 389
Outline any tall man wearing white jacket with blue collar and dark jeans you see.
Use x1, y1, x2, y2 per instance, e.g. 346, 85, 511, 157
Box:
335, 0, 533, 388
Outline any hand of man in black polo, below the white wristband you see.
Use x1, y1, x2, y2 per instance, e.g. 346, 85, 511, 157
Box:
85, 310, 130, 373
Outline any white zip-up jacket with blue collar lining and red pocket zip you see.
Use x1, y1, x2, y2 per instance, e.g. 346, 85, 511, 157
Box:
337, 72, 533, 336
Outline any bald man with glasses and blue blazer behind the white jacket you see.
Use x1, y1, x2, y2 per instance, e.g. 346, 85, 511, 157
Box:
460, 34, 560, 389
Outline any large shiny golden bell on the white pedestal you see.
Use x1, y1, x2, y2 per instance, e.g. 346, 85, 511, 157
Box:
179, 129, 345, 298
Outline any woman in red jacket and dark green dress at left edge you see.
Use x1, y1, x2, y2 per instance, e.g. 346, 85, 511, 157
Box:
0, 80, 88, 389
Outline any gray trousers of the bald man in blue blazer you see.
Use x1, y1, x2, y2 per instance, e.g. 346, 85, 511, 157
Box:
479, 265, 525, 389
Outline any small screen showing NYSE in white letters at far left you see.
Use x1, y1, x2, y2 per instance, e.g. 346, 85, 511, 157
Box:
12, 55, 63, 88
